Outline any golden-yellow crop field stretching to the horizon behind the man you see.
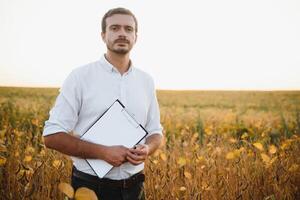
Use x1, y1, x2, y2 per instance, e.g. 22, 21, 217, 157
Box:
0, 87, 300, 200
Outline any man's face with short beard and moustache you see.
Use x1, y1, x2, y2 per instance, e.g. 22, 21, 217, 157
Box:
101, 14, 137, 54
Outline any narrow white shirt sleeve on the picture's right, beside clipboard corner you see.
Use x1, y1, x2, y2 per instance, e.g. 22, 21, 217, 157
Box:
145, 78, 163, 137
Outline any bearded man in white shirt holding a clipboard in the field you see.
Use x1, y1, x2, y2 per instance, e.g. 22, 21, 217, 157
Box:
43, 8, 162, 200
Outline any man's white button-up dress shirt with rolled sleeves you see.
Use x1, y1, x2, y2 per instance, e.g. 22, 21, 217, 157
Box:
43, 55, 162, 180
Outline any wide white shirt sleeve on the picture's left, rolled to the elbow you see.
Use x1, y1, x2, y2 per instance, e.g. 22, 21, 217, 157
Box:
43, 71, 81, 136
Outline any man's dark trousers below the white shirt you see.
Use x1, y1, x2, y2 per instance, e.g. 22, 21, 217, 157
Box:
71, 169, 145, 200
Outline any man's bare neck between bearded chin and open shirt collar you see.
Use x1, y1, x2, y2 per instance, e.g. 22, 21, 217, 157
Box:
105, 51, 130, 75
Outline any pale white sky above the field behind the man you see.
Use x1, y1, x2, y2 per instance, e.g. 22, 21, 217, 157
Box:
0, 0, 300, 90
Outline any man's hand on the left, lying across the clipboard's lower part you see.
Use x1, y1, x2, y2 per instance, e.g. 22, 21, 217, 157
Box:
104, 146, 128, 167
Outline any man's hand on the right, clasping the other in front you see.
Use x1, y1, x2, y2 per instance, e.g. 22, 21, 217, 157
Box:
126, 144, 149, 165
